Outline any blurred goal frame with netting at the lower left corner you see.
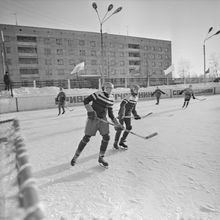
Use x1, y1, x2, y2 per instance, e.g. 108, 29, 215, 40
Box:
0, 119, 44, 220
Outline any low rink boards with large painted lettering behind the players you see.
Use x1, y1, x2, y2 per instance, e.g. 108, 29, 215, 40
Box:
0, 83, 220, 113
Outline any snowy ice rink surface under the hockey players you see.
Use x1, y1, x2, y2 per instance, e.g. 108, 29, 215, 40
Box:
1, 95, 220, 220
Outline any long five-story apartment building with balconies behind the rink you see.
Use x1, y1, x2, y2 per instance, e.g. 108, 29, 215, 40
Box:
0, 24, 172, 87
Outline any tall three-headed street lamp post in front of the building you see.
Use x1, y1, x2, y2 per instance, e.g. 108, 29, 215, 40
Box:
92, 2, 122, 82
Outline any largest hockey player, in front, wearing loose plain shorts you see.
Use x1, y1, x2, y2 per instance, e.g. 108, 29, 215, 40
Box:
70, 82, 121, 168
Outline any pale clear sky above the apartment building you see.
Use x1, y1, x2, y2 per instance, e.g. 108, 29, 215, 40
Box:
0, 0, 220, 77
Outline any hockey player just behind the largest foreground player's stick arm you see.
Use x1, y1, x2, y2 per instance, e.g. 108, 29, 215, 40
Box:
113, 85, 141, 150
